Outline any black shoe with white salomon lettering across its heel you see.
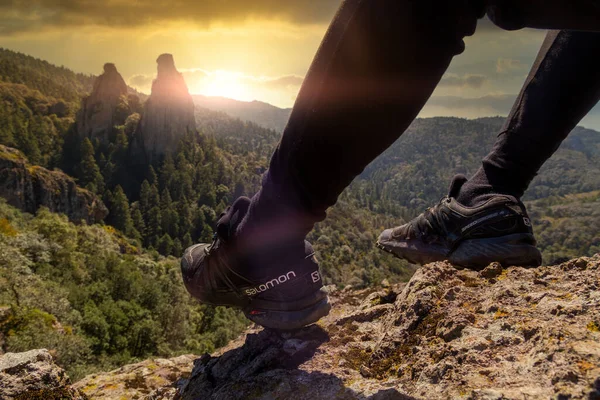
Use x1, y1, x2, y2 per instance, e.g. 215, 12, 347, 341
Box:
181, 197, 331, 330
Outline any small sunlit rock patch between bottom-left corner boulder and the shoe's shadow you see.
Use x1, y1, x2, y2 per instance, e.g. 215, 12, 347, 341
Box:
74, 355, 196, 400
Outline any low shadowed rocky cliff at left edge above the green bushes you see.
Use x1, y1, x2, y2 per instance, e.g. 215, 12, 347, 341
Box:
0, 145, 108, 223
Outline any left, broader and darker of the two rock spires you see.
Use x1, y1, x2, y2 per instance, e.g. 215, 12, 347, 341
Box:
77, 63, 129, 143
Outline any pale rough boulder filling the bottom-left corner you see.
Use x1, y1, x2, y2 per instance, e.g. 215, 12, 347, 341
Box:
0, 350, 87, 400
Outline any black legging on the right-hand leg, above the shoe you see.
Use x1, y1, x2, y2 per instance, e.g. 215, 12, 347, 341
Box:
461, 31, 600, 202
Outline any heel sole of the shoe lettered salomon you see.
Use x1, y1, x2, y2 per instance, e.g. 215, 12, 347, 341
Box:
244, 291, 331, 331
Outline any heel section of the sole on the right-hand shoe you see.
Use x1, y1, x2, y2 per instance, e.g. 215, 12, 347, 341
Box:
449, 233, 542, 269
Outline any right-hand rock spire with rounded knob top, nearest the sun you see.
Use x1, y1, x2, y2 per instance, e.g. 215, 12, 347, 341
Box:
134, 54, 196, 161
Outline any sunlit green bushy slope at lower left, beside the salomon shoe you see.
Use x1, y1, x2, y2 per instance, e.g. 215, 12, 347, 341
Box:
0, 199, 247, 379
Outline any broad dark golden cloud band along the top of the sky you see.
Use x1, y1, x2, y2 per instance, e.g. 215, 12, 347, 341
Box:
0, 0, 339, 36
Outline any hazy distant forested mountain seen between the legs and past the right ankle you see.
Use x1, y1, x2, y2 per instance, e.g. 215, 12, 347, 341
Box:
361, 118, 600, 215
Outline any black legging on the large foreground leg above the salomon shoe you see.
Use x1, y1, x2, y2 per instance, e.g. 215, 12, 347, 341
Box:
250, 0, 484, 236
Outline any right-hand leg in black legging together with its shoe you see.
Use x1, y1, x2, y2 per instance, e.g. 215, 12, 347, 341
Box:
378, 31, 600, 269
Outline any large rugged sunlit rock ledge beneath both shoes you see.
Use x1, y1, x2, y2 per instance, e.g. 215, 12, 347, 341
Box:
176, 255, 600, 400
